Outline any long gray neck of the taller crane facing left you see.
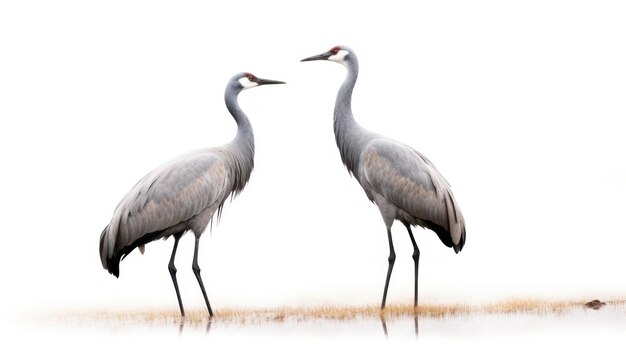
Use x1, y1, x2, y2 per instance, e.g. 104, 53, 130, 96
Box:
333, 53, 370, 176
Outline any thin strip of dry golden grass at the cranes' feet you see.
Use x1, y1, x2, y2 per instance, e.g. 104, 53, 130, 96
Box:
55, 299, 626, 325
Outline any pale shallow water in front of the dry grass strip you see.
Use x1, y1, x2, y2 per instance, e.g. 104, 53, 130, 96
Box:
22, 305, 626, 349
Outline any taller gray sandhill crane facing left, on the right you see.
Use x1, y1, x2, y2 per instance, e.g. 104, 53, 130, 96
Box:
302, 46, 465, 309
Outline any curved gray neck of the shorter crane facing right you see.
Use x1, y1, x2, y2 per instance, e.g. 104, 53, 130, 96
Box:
224, 84, 254, 193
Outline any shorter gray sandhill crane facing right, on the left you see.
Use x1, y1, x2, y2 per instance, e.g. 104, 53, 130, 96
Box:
100, 73, 284, 316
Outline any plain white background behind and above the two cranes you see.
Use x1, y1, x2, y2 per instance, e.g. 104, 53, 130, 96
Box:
0, 1, 626, 346
